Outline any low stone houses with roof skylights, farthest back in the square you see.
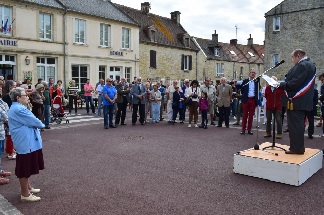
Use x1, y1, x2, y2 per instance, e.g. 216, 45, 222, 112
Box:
194, 31, 264, 80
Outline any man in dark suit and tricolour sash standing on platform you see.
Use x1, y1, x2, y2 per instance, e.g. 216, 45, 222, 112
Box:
280, 49, 316, 154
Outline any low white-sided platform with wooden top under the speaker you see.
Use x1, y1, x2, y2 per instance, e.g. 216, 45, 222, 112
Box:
233, 142, 323, 186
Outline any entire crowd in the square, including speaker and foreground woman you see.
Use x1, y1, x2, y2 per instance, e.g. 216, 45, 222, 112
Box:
0, 50, 324, 201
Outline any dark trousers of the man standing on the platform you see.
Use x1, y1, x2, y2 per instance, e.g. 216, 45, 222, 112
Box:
287, 110, 305, 152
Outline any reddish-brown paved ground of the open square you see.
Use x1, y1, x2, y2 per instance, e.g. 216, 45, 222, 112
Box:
0, 110, 324, 215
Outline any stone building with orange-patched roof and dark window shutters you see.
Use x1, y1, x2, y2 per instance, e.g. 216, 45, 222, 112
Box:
116, 2, 199, 83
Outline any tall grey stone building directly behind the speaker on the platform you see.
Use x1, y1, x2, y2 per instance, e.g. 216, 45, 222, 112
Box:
265, 0, 324, 79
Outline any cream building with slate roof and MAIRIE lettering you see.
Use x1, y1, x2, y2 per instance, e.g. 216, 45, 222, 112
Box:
0, 0, 139, 89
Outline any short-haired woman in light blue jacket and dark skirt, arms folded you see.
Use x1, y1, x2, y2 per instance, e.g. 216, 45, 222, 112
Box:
8, 87, 45, 202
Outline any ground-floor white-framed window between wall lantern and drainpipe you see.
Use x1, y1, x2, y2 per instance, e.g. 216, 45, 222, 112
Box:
37, 57, 56, 81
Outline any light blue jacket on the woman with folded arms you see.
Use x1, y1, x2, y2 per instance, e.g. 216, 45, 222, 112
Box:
8, 102, 45, 154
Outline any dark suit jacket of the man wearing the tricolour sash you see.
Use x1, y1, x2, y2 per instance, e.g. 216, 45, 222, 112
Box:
280, 58, 316, 111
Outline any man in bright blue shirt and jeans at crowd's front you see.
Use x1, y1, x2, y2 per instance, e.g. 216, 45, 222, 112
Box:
102, 78, 117, 129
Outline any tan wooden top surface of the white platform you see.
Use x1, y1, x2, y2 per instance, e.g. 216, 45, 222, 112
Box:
238, 142, 321, 165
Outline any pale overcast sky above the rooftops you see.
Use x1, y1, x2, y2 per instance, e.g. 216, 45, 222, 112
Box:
112, 0, 283, 44
